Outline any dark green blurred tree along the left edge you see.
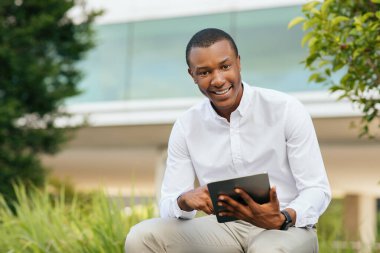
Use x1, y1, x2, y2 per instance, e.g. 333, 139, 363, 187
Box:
0, 0, 100, 204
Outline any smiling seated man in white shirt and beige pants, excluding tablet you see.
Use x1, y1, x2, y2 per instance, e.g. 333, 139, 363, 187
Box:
125, 29, 331, 253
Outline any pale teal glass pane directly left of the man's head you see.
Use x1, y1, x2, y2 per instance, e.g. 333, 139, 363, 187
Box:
129, 14, 230, 99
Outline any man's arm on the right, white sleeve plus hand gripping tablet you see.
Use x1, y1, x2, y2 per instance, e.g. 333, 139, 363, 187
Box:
215, 96, 331, 229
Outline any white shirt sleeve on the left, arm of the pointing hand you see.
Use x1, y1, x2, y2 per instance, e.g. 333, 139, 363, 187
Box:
160, 120, 196, 219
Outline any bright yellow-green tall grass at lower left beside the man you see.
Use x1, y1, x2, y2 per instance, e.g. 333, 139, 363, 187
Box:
0, 185, 155, 253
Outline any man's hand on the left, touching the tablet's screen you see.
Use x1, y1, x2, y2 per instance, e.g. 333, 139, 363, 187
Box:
177, 185, 214, 214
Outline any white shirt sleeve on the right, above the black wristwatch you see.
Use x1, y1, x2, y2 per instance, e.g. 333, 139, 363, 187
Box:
285, 99, 331, 227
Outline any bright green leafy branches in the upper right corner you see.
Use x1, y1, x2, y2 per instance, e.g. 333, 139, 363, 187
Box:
288, 0, 380, 137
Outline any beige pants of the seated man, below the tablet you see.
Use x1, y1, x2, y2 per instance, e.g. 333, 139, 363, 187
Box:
125, 215, 318, 253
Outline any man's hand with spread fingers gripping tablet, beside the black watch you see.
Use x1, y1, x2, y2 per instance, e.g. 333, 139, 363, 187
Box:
218, 187, 296, 229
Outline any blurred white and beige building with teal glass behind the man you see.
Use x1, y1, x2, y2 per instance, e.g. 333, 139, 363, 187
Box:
1, 0, 380, 253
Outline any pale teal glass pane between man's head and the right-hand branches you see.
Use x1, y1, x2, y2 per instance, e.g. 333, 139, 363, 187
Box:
235, 6, 324, 92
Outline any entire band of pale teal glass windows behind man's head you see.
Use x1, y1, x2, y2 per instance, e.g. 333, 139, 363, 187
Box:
70, 6, 325, 103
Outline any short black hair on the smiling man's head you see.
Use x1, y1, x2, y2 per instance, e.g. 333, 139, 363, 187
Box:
186, 28, 239, 67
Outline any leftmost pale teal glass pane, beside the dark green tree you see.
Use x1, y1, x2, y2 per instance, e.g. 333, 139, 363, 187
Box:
69, 23, 130, 103
